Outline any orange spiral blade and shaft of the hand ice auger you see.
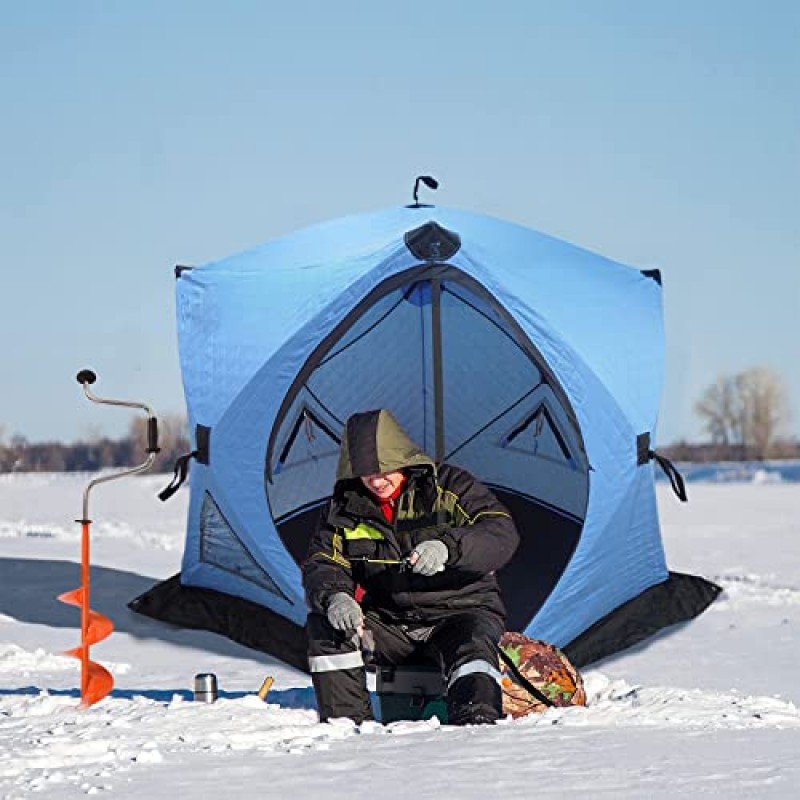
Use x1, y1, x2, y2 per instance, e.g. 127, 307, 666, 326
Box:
58, 520, 114, 706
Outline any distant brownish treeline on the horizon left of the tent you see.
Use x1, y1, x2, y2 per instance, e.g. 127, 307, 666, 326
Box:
0, 416, 190, 472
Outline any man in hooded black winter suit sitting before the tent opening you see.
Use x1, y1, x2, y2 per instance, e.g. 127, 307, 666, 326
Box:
303, 409, 519, 725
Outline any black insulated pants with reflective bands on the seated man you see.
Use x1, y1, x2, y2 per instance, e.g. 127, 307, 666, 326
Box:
306, 610, 504, 725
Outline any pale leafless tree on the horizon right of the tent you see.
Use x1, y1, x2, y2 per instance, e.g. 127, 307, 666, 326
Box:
695, 367, 789, 460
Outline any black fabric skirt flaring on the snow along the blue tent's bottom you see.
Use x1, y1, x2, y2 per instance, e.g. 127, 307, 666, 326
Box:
128, 572, 722, 672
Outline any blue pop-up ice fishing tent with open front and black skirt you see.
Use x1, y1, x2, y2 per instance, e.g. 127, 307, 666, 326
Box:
131, 188, 718, 667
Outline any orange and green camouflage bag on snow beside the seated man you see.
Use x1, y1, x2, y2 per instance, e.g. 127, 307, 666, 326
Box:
499, 632, 586, 719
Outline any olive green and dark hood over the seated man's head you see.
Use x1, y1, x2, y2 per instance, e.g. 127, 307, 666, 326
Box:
336, 408, 435, 482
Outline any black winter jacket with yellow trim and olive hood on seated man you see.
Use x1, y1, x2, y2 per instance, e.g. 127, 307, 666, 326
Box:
303, 411, 519, 624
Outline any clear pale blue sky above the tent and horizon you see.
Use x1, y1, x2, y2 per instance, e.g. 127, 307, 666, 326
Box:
0, 0, 800, 444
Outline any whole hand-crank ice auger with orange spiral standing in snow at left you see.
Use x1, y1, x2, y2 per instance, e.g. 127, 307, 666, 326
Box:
58, 369, 159, 706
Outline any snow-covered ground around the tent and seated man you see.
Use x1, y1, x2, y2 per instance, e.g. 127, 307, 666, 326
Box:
0, 470, 800, 800
